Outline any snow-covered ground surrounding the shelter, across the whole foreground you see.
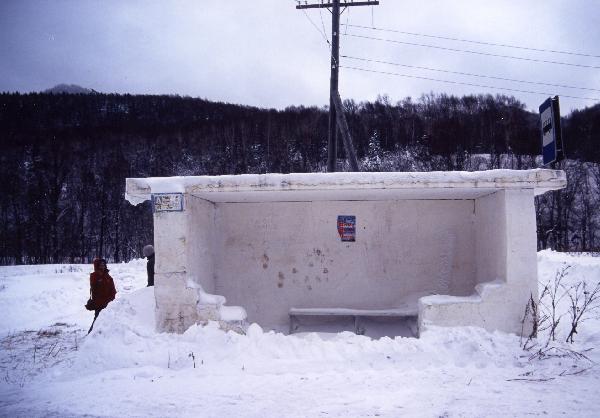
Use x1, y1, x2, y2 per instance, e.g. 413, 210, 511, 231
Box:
0, 252, 600, 418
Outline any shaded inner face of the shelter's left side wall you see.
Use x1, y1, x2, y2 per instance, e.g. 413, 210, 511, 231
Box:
186, 196, 215, 293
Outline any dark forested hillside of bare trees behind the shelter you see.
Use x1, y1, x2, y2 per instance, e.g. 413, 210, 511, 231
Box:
0, 93, 600, 264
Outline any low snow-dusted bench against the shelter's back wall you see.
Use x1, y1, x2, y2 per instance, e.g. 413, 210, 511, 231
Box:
289, 306, 418, 334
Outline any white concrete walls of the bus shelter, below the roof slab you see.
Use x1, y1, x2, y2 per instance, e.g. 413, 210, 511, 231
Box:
154, 189, 537, 332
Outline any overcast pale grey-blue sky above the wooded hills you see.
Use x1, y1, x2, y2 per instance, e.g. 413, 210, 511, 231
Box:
0, 0, 600, 114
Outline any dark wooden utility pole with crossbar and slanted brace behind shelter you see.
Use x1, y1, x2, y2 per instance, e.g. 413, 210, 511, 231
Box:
296, 0, 379, 172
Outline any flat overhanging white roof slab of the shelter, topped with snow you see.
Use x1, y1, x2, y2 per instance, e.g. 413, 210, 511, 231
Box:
125, 169, 567, 205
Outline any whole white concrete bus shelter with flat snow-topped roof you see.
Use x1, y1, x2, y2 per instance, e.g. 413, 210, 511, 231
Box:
126, 169, 566, 333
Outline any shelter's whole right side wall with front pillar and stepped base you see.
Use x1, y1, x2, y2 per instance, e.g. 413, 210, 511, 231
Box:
419, 189, 538, 335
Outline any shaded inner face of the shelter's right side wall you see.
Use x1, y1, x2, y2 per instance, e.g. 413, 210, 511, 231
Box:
475, 190, 506, 283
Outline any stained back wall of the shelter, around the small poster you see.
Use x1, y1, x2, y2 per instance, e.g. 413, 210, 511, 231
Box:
213, 200, 476, 327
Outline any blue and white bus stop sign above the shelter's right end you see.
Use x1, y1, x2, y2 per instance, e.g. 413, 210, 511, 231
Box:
540, 96, 564, 166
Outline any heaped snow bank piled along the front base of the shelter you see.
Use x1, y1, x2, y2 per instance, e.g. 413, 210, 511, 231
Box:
74, 302, 521, 377
